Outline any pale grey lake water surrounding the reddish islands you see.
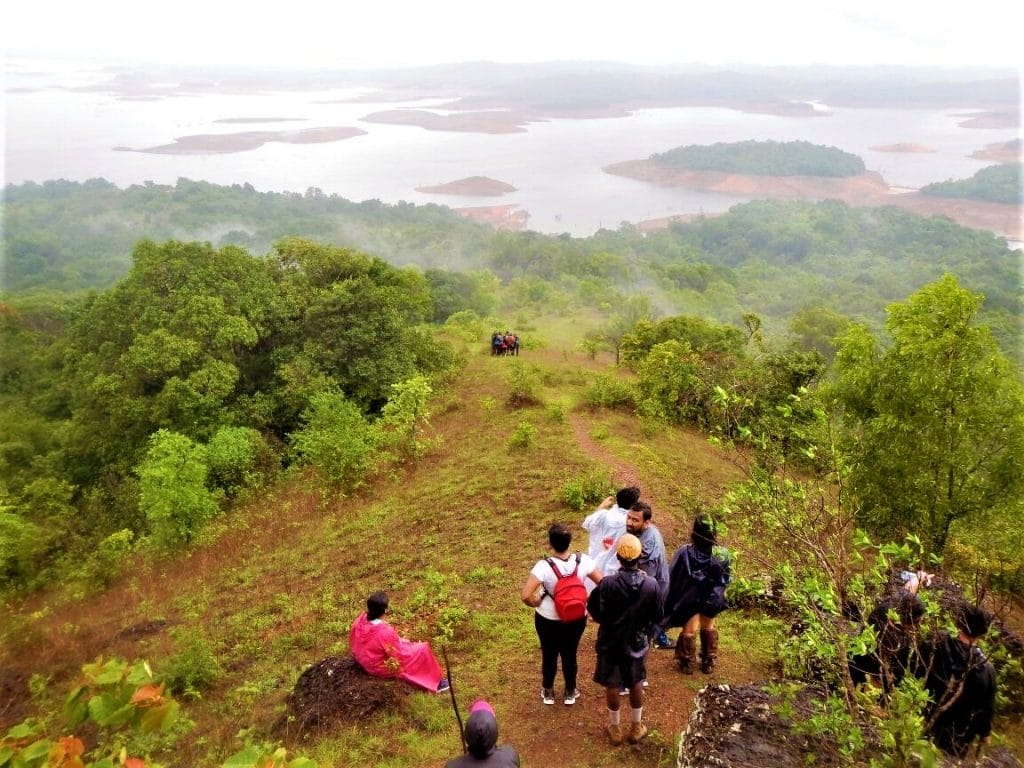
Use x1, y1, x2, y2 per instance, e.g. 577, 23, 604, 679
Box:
3, 60, 1017, 236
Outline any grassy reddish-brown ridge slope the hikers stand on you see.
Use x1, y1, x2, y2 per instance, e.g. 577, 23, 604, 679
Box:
0, 321, 1020, 768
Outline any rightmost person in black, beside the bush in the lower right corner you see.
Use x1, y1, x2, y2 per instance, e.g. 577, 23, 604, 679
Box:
915, 603, 995, 758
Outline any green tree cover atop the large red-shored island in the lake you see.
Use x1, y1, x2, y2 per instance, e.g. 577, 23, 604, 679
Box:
650, 140, 864, 176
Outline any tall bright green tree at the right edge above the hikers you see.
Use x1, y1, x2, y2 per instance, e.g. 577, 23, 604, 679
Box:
833, 275, 1024, 552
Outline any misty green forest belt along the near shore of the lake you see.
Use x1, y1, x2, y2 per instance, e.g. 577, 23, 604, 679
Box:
4, 179, 1022, 358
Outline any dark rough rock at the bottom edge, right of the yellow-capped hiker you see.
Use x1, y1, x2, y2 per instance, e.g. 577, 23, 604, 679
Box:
676, 685, 843, 768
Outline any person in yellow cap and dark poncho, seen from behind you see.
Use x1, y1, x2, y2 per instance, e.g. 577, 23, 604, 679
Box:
587, 534, 662, 746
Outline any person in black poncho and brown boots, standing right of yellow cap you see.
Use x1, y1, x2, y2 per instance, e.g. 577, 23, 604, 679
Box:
662, 513, 729, 675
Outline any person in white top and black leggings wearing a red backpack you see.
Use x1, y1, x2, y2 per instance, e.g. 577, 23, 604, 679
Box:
520, 522, 601, 706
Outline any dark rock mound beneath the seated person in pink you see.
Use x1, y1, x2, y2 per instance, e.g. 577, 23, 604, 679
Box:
278, 656, 409, 736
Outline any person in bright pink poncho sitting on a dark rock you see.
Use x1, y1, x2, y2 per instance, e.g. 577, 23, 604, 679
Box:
348, 592, 449, 693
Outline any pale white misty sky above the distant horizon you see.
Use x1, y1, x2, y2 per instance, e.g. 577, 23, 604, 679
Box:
6, 0, 1024, 72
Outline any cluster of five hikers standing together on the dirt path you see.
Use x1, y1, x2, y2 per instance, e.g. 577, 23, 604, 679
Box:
520, 486, 730, 745
